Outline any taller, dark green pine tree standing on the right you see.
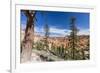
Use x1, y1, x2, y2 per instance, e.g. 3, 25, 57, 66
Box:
69, 17, 78, 59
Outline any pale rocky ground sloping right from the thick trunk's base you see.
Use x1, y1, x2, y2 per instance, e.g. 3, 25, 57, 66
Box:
26, 49, 63, 62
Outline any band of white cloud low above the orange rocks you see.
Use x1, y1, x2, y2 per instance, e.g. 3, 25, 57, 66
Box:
21, 24, 89, 37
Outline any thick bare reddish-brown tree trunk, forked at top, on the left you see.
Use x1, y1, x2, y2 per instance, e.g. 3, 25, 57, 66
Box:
21, 10, 35, 62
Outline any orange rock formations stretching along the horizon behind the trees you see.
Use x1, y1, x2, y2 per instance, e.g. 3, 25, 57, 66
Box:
21, 31, 89, 48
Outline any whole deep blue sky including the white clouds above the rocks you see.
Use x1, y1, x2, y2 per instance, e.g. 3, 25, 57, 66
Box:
21, 11, 89, 36
